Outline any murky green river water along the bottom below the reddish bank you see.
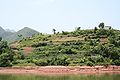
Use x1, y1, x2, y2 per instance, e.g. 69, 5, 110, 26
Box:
0, 74, 120, 80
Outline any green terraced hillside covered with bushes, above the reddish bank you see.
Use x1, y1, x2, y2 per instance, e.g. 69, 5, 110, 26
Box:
0, 23, 120, 66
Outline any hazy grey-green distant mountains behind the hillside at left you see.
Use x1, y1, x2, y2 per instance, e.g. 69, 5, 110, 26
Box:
0, 27, 39, 43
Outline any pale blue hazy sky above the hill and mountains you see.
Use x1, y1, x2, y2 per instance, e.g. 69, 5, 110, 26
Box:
0, 0, 120, 33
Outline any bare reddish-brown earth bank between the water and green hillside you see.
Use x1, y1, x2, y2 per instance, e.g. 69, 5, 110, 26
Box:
0, 66, 120, 75
